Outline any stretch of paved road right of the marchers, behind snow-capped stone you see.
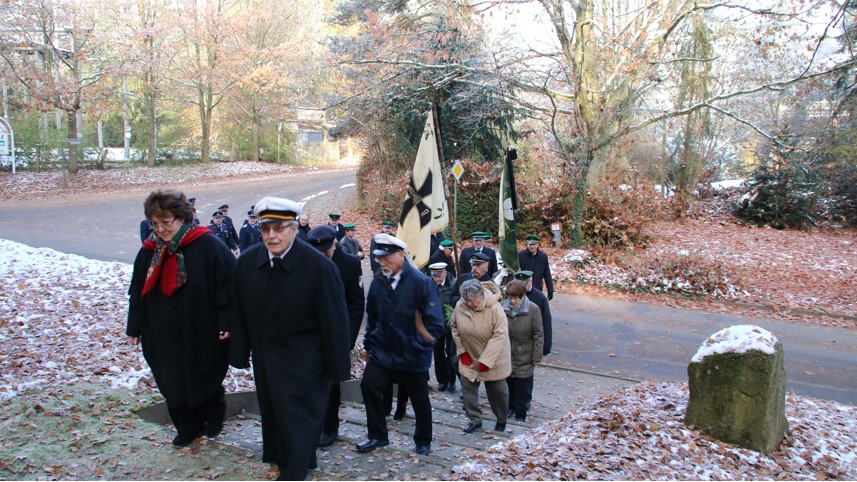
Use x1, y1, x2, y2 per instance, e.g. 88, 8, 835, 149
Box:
548, 295, 857, 405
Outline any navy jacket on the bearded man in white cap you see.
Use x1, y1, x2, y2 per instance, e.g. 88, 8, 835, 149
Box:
363, 262, 444, 372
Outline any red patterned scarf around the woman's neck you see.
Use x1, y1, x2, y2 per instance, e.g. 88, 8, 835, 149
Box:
140, 223, 211, 296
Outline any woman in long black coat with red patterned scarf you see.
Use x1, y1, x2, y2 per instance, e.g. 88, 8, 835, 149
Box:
125, 190, 235, 447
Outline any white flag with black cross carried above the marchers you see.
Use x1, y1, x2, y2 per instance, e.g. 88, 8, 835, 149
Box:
396, 112, 449, 269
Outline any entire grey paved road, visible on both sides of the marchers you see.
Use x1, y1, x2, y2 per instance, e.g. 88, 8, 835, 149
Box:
0, 170, 857, 404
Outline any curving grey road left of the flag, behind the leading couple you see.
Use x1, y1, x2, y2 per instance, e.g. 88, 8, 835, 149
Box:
0, 169, 355, 263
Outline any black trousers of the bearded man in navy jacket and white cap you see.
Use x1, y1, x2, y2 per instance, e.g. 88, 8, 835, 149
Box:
360, 358, 432, 446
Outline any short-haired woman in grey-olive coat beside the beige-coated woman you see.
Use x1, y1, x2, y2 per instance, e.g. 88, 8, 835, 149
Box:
502, 280, 545, 422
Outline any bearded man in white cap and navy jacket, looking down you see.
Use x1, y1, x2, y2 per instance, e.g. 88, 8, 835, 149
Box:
357, 234, 444, 455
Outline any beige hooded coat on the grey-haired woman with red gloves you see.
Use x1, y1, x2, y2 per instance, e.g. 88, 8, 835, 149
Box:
450, 289, 512, 382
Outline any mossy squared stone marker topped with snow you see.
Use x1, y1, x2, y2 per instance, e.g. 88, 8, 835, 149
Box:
684, 325, 789, 453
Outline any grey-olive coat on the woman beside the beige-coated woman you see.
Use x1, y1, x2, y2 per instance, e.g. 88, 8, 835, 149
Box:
503, 296, 545, 378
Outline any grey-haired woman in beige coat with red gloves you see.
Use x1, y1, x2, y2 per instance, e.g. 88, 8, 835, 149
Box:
450, 279, 512, 433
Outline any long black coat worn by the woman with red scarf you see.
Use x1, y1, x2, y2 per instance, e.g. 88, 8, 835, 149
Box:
125, 233, 235, 407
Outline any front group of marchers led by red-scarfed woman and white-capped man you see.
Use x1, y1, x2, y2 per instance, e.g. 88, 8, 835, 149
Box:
126, 190, 552, 480
